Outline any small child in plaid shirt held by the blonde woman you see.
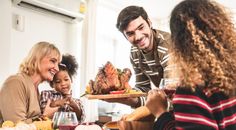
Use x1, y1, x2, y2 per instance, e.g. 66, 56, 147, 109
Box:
40, 54, 84, 122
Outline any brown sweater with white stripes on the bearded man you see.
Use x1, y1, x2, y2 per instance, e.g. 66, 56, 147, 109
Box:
130, 29, 170, 105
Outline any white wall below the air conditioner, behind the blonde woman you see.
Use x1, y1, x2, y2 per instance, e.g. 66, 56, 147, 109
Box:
0, 0, 81, 93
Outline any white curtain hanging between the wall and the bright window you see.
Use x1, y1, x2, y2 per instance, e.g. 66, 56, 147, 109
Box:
80, 0, 98, 122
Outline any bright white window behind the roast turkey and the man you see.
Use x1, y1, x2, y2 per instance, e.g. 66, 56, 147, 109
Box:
95, 3, 134, 114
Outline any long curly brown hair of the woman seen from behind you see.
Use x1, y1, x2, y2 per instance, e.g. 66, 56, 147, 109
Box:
170, 0, 236, 95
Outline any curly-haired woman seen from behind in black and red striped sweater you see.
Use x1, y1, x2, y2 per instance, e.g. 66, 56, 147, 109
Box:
146, 0, 236, 130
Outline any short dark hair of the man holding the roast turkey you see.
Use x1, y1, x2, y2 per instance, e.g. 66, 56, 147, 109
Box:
116, 6, 149, 33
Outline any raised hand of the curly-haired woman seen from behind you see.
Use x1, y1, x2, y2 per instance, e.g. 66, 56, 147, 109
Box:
146, 89, 168, 118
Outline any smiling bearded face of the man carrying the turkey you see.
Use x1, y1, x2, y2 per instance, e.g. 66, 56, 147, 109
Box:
123, 16, 152, 52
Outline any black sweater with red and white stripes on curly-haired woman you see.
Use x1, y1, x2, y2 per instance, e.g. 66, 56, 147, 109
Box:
154, 88, 236, 130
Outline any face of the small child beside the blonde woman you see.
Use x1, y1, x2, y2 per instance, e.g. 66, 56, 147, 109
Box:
53, 70, 72, 95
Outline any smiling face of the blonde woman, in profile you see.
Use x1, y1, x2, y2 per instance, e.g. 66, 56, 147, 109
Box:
38, 53, 60, 81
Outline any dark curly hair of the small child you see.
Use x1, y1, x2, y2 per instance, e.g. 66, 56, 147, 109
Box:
50, 54, 78, 87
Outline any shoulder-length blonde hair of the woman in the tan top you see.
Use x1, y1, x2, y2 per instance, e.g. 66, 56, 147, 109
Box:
19, 42, 61, 76
